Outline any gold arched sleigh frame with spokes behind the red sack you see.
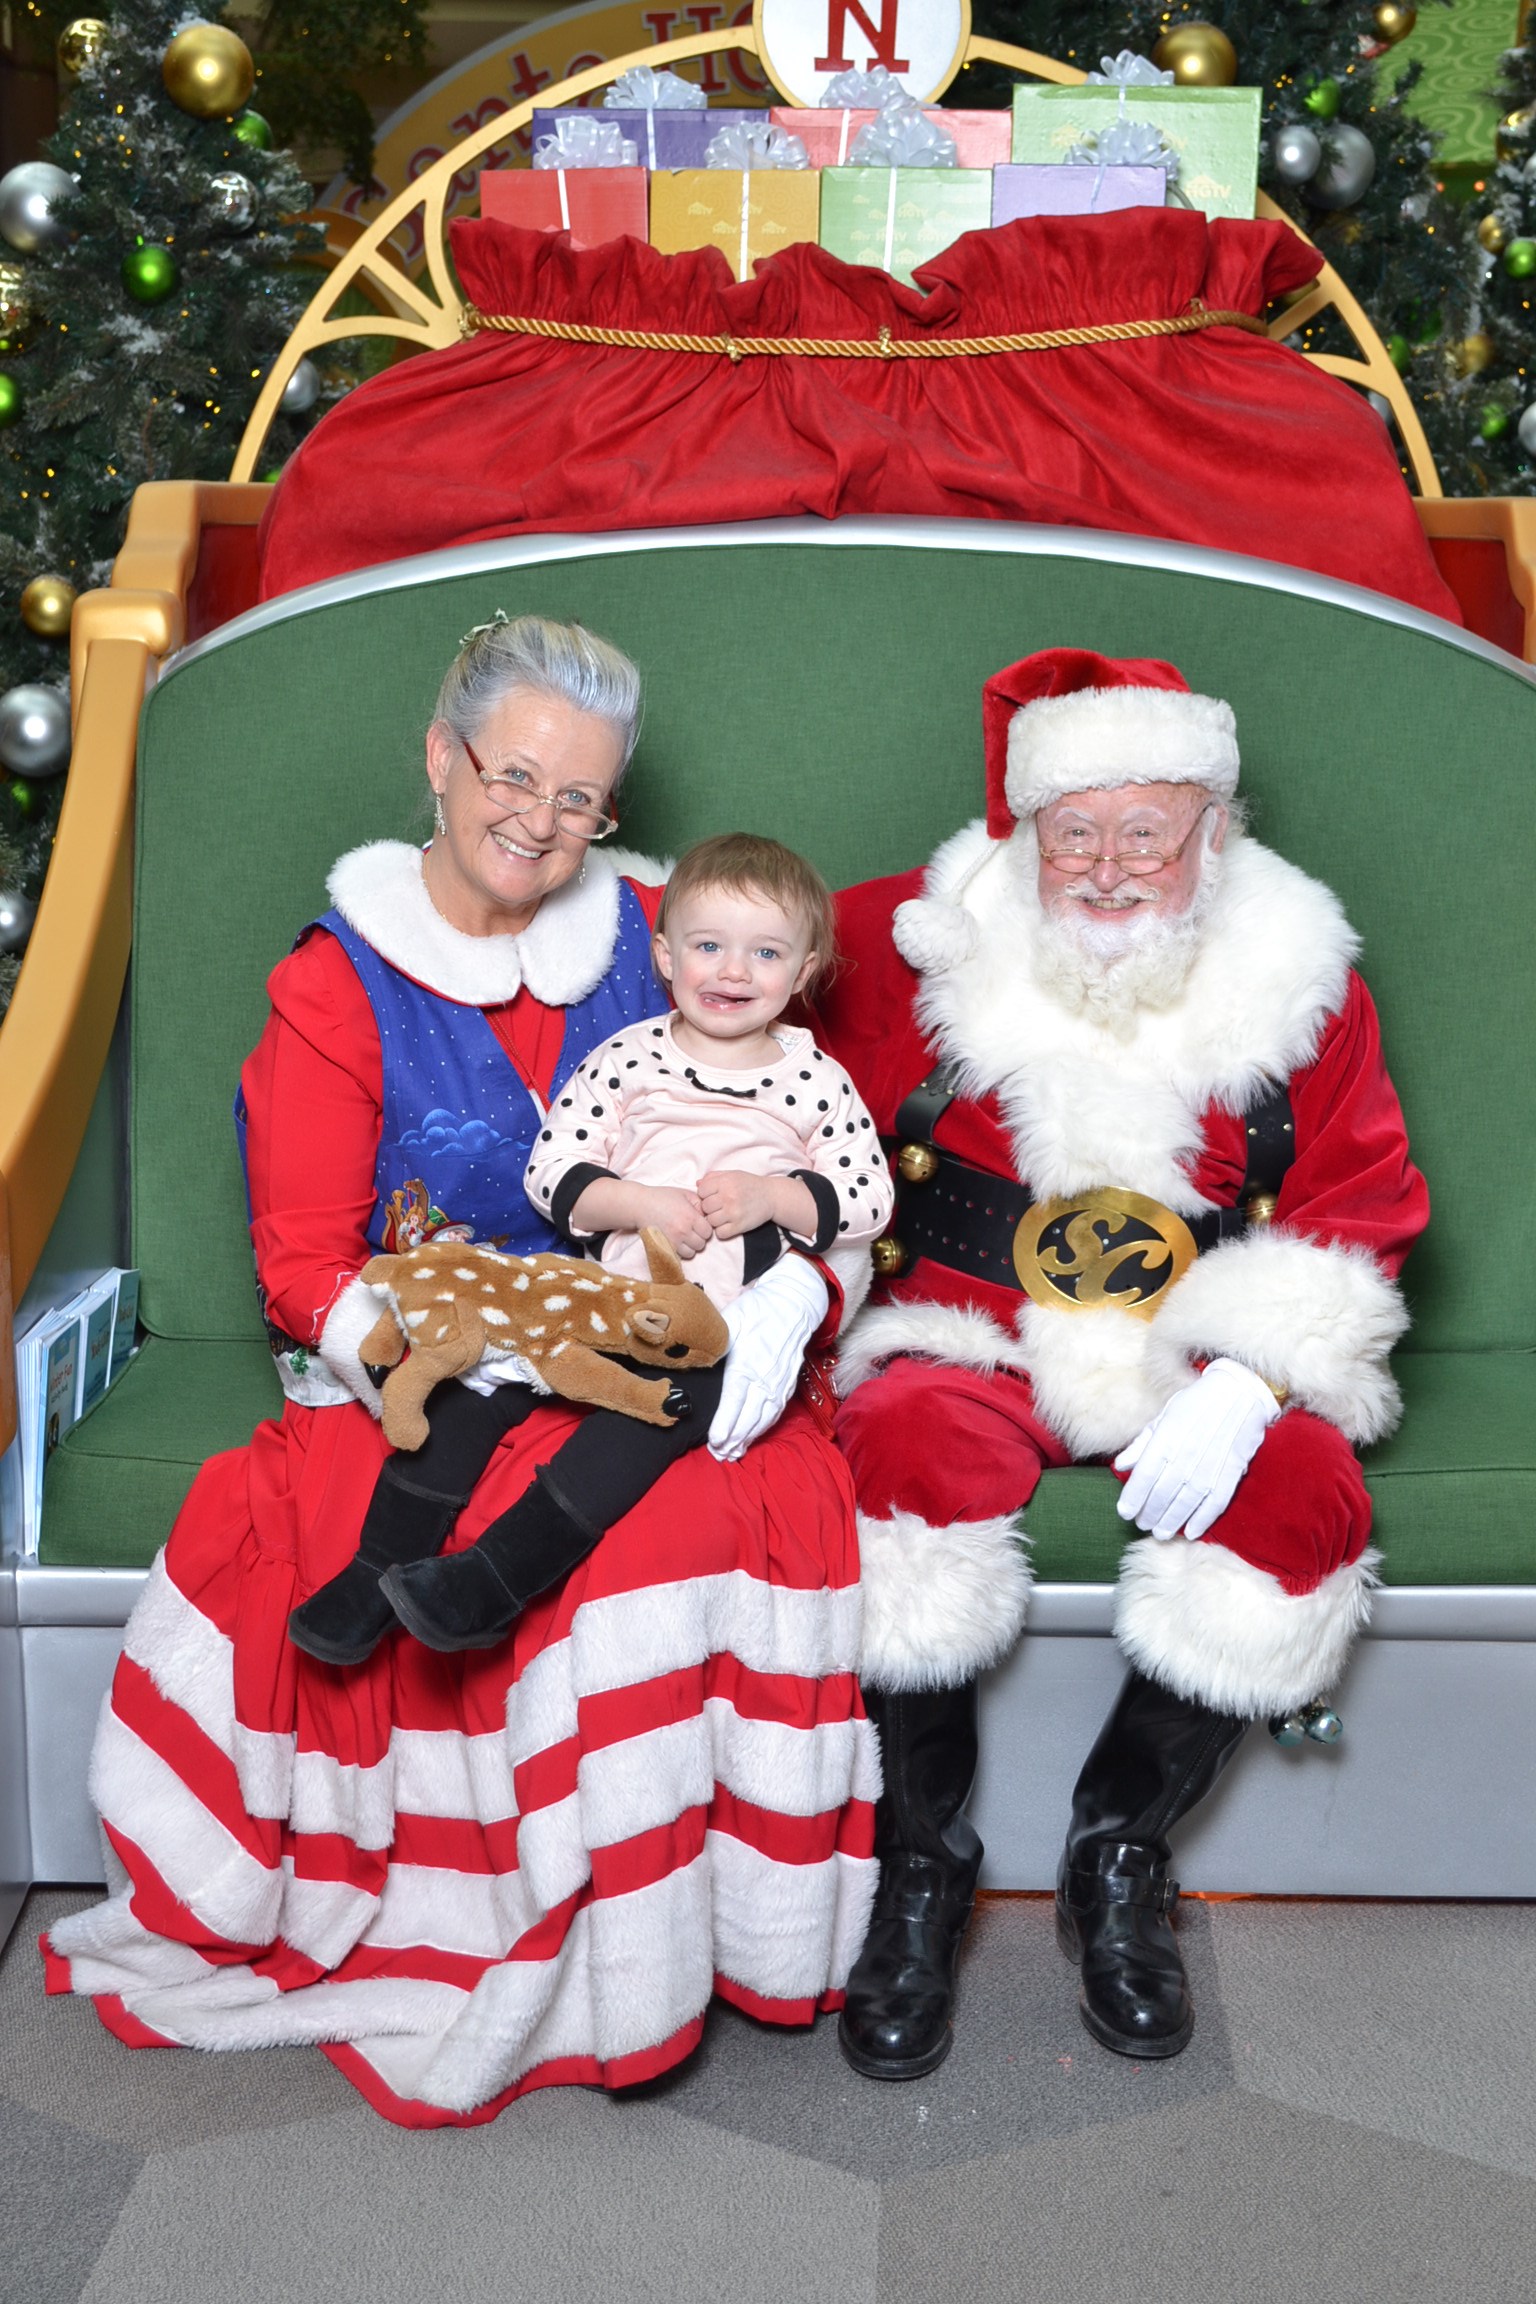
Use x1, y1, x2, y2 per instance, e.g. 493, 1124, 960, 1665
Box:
230, 23, 1442, 498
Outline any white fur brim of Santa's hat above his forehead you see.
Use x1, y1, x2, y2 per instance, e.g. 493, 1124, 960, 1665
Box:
1004, 689, 1239, 823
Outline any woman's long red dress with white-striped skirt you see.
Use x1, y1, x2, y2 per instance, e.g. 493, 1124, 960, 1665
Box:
46, 912, 877, 2127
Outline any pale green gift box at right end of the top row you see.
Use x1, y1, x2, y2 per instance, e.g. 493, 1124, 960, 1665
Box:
1013, 83, 1262, 217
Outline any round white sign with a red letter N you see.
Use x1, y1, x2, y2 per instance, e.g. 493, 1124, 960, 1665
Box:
753, 0, 972, 106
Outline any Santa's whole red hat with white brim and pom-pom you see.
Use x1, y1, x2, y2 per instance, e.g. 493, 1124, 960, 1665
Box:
896, 647, 1239, 975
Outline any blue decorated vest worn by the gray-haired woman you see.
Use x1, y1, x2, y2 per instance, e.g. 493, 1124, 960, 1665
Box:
235, 880, 666, 1405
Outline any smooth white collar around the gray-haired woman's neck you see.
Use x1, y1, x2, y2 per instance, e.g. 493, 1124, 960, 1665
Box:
327, 841, 666, 1007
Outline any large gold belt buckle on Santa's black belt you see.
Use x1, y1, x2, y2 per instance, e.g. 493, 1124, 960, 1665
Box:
1013, 1184, 1200, 1320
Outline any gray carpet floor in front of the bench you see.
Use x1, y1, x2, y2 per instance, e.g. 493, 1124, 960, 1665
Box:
0, 1889, 1536, 2304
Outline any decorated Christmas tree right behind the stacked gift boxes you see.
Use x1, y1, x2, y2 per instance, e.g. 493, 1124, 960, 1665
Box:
958, 0, 1492, 495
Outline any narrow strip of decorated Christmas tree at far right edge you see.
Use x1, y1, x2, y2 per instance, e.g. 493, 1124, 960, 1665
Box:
1467, 27, 1536, 495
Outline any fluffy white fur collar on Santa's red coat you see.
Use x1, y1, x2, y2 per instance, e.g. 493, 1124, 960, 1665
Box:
917, 823, 1356, 1214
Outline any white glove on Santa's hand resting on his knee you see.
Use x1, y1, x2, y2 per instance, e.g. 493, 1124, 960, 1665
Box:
1115, 1359, 1280, 1544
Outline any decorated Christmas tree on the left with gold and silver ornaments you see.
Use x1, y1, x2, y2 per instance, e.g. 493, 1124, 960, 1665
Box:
0, 0, 322, 1005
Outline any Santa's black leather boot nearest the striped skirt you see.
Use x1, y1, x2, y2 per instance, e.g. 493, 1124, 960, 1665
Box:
838, 1680, 981, 2081
